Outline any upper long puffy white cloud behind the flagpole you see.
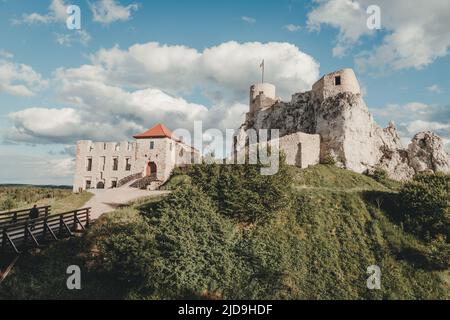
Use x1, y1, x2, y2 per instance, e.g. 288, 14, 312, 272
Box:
57, 41, 319, 101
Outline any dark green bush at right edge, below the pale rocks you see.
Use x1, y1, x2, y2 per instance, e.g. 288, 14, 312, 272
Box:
399, 173, 450, 241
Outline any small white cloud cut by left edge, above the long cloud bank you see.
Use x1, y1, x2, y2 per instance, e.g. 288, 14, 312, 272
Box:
0, 59, 48, 96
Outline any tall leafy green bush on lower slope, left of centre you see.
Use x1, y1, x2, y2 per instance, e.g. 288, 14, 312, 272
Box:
145, 187, 234, 299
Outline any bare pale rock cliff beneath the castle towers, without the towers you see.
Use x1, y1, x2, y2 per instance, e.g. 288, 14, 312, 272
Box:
238, 91, 450, 180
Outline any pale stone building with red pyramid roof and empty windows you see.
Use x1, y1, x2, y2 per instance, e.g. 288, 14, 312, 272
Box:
73, 124, 200, 192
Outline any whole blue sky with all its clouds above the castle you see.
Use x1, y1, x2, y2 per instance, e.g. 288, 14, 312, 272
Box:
0, 0, 450, 184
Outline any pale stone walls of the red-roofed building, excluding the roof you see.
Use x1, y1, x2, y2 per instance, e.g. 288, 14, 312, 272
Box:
73, 138, 199, 192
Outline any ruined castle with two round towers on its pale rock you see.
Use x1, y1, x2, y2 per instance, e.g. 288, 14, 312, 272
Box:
234, 68, 450, 180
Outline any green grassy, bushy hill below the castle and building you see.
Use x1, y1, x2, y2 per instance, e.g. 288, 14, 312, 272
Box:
0, 165, 450, 299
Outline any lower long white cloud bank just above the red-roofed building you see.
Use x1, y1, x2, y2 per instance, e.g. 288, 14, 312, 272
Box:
4, 81, 207, 144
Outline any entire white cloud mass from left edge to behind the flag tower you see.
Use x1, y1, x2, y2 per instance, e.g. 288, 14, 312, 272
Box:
4, 42, 319, 149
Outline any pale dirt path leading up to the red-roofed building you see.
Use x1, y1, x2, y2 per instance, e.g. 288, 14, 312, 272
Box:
83, 187, 167, 220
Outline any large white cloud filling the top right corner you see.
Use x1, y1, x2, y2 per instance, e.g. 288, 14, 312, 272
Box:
307, 0, 450, 71
